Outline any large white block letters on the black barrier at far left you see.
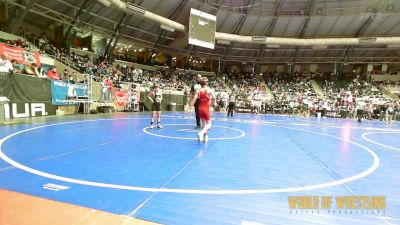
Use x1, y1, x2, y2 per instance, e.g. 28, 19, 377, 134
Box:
4, 103, 48, 119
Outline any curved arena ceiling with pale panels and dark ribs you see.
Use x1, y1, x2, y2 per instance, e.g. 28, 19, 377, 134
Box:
1, 0, 400, 63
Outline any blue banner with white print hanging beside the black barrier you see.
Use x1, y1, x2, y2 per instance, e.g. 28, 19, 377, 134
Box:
51, 80, 87, 105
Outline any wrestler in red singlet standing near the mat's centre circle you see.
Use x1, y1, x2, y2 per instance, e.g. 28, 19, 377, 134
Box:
190, 78, 216, 142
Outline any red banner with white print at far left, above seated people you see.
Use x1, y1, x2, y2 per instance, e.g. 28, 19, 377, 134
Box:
0, 43, 40, 66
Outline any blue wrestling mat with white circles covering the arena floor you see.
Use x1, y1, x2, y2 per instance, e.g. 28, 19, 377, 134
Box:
0, 113, 400, 225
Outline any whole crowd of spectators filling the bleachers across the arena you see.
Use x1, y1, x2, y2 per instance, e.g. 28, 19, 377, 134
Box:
0, 30, 400, 120
